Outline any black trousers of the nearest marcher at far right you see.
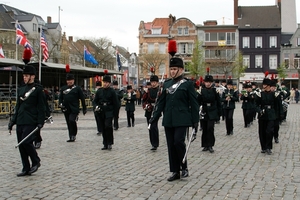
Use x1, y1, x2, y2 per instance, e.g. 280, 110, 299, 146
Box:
258, 120, 274, 150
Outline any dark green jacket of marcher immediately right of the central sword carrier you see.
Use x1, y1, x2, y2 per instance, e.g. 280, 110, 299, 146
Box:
198, 87, 221, 120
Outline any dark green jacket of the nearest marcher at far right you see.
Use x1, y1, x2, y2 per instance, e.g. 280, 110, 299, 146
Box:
255, 91, 281, 121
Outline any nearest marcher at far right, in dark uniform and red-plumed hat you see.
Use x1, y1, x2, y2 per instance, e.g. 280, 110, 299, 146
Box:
256, 72, 280, 155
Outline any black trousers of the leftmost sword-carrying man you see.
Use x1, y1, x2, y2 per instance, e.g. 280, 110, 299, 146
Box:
17, 125, 41, 171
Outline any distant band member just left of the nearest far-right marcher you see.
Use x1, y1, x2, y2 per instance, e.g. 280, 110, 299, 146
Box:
241, 82, 255, 128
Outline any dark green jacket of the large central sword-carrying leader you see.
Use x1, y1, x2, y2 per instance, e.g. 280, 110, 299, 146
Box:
153, 77, 199, 127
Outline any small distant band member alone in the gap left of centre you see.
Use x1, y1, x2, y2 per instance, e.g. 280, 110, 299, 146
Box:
124, 85, 136, 127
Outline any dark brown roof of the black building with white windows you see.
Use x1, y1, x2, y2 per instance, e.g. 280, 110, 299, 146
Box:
238, 6, 281, 29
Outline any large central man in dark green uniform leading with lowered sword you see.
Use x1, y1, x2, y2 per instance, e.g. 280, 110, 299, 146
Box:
149, 58, 199, 181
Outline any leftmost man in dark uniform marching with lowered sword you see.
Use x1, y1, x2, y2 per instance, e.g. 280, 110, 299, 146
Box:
8, 65, 45, 176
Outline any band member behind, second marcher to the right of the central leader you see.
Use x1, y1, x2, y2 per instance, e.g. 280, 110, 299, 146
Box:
221, 79, 239, 135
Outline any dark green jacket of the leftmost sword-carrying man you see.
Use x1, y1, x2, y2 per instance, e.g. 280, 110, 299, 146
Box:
12, 83, 46, 125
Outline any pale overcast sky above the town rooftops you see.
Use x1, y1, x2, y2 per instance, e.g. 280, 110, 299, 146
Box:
5, 0, 300, 53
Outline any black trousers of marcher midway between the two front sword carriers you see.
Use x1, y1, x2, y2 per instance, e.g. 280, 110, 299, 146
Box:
100, 116, 114, 147
